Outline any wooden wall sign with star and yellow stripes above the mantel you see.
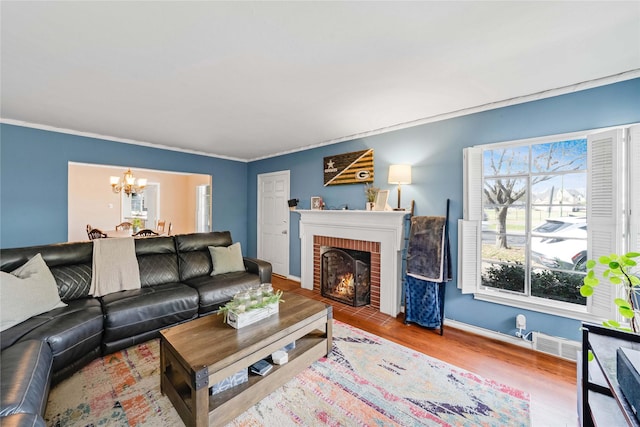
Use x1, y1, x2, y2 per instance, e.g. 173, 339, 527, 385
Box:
322, 148, 373, 187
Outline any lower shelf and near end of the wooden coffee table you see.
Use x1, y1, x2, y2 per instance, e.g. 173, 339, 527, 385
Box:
160, 306, 332, 427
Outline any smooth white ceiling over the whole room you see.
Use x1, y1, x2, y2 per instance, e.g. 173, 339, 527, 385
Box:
0, 1, 640, 160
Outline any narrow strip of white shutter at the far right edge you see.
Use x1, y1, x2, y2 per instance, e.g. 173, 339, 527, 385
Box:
627, 125, 640, 252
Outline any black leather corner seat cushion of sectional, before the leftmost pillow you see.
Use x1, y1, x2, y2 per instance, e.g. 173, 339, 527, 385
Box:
2, 298, 103, 372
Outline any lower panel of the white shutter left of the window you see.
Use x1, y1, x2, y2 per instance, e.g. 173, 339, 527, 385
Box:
458, 219, 481, 294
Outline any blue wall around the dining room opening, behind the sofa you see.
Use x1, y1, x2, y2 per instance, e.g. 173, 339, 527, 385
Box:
0, 124, 247, 248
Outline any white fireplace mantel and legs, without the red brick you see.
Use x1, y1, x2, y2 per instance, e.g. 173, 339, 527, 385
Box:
296, 210, 407, 317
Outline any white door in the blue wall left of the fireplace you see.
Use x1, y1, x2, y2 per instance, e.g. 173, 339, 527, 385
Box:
258, 171, 289, 277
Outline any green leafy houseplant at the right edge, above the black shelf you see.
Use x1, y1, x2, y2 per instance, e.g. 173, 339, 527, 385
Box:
580, 252, 640, 333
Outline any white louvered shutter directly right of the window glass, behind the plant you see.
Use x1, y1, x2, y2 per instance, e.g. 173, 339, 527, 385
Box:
587, 129, 623, 319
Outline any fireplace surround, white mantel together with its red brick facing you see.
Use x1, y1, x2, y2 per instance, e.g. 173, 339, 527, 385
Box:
296, 210, 406, 316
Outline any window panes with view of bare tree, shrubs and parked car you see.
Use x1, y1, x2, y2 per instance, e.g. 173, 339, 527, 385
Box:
481, 139, 587, 305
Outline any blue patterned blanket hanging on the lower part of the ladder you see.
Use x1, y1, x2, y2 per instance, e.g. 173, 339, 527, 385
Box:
404, 275, 445, 328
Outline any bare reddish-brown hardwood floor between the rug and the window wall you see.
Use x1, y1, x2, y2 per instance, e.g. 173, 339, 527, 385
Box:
272, 275, 578, 427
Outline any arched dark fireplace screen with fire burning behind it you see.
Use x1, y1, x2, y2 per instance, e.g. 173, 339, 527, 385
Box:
320, 247, 371, 307
